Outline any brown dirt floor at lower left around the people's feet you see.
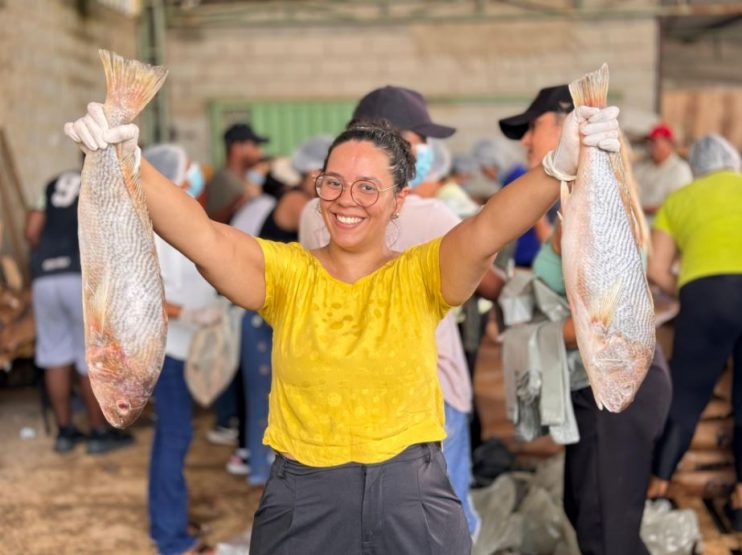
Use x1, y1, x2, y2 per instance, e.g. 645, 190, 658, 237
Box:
0, 380, 262, 555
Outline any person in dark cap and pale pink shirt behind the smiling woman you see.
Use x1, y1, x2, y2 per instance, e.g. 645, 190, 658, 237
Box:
299, 86, 503, 536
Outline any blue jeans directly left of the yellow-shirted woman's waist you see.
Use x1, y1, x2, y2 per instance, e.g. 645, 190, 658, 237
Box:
240, 310, 274, 485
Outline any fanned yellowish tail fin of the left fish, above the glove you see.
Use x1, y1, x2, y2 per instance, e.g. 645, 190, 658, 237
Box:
98, 49, 167, 126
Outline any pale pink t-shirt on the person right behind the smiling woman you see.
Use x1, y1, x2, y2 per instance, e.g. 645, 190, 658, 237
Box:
299, 194, 472, 413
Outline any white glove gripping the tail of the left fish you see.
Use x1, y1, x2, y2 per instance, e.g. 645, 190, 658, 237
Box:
64, 102, 141, 167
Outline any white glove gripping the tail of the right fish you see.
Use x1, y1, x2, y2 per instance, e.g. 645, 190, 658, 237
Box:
544, 106, 621, 181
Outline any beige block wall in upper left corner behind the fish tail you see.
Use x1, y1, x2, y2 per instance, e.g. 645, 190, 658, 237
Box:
0, 0, 137, 201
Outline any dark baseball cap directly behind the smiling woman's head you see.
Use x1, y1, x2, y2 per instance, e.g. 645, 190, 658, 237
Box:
353, 85, 456, 139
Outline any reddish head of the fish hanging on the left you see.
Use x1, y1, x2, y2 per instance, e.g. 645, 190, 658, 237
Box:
88, 336, 157, 428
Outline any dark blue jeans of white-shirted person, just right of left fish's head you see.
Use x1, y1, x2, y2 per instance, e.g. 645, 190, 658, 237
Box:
148, 356, 196, 555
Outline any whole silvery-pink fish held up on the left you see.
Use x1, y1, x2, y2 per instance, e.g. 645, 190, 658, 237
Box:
78, 50, 167, 428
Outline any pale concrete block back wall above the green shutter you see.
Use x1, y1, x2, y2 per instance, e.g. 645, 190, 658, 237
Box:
164, 17, 658, 164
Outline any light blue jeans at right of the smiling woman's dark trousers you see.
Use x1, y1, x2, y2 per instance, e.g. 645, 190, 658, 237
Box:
443, 403, 480, 535
